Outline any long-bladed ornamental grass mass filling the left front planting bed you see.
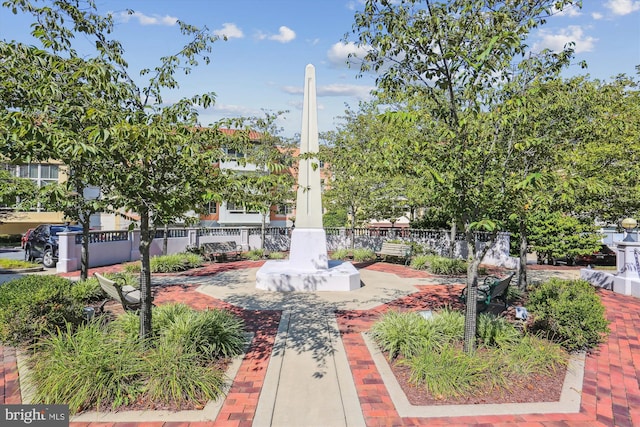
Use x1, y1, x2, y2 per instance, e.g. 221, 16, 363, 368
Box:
29, 304, 246, 413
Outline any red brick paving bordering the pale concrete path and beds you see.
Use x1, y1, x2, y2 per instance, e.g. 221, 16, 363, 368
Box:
0, 261, 640, 427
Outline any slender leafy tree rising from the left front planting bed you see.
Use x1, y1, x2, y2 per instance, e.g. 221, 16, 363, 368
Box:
0, 0, 246, 338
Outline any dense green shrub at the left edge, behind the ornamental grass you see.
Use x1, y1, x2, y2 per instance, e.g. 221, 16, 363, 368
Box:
0, 275, 83, 345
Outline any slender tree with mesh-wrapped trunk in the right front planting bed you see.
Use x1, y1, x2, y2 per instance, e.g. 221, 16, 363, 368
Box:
353, 0, 574, 352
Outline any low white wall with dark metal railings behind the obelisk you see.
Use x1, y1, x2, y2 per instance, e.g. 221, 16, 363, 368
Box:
56, 227, 516, 273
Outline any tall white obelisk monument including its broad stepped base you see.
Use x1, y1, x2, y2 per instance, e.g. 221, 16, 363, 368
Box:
256, 64, 360, 291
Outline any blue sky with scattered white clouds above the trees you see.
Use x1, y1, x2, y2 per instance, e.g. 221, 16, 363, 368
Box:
0, 0, 640, 137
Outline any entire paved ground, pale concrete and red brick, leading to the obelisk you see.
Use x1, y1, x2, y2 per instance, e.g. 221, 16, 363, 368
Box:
0, 261, 640, 427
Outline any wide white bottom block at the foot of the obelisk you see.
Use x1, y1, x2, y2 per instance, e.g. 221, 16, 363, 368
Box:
256, 260, 360, 292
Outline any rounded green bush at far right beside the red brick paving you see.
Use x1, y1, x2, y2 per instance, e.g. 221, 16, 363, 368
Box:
527, 279, 609, 351
